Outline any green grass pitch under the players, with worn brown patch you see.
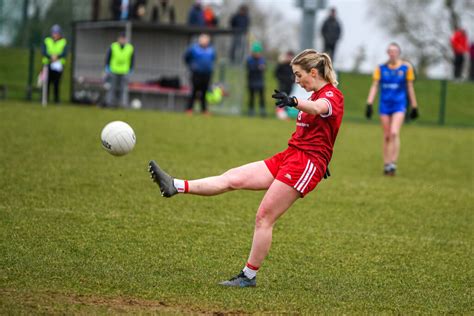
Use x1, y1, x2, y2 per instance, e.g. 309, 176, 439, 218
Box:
0, 102, 474, 314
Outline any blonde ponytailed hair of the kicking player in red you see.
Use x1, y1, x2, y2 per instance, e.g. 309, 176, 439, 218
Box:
291, 49, 338, 86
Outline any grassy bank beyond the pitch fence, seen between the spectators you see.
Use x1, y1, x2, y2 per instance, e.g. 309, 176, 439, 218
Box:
0, 47, 474, 127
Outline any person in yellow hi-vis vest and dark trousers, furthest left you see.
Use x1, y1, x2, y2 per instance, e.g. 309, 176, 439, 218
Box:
42, 24, 68, 103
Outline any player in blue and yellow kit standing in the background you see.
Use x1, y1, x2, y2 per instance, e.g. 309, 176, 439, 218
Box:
365, 43, 418, 176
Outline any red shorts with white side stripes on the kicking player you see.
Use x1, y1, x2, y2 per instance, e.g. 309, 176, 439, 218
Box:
264, 147, 326, 197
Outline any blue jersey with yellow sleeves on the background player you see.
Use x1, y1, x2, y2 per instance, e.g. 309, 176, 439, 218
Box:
373, 62, 415, 107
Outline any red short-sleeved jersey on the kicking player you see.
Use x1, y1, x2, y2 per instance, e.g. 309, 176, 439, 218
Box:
288, 83, 344, 165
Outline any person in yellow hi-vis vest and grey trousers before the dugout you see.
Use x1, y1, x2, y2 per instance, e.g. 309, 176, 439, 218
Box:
105, 33, 134, 107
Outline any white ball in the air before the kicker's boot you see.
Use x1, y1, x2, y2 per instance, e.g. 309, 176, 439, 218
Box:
100, 121, 136, 156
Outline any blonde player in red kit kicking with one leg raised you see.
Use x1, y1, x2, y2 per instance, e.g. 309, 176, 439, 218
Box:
149, 49, 344, 287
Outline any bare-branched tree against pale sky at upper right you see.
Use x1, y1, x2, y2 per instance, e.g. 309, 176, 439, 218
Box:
371, 0, 474, 76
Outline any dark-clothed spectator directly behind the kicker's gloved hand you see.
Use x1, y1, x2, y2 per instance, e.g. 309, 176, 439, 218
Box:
275, 51, 298, 119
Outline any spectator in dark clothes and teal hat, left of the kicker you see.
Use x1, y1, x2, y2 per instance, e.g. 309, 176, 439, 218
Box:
247, 42, 266, 117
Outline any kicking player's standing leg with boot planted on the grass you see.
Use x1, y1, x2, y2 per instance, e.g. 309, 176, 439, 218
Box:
220, 180, 300, 287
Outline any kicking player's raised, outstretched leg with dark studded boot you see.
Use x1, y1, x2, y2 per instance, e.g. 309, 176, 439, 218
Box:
150, 161, 274, 197
